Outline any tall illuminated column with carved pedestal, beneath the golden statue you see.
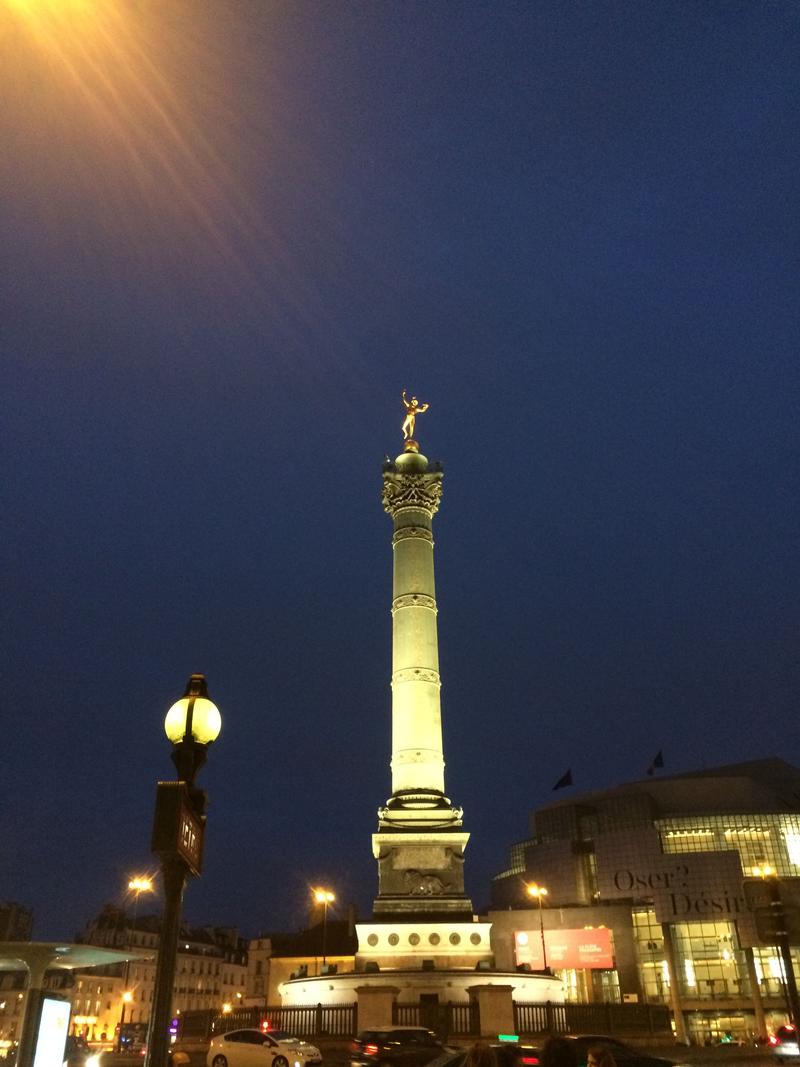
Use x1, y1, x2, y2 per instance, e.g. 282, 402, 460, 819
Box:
372, 440, 471, 919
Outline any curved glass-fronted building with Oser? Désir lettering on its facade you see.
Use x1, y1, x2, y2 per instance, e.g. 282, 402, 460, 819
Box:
490, 759, 800, 1040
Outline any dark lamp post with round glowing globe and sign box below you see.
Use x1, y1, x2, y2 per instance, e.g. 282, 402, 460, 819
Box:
146, 674, 222, 1067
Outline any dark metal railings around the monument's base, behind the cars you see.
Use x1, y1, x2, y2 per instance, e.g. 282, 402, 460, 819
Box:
178, 1003, 672, 1041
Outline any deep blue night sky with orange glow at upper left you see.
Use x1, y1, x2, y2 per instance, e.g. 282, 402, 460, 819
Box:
0, 6, 800, 939
